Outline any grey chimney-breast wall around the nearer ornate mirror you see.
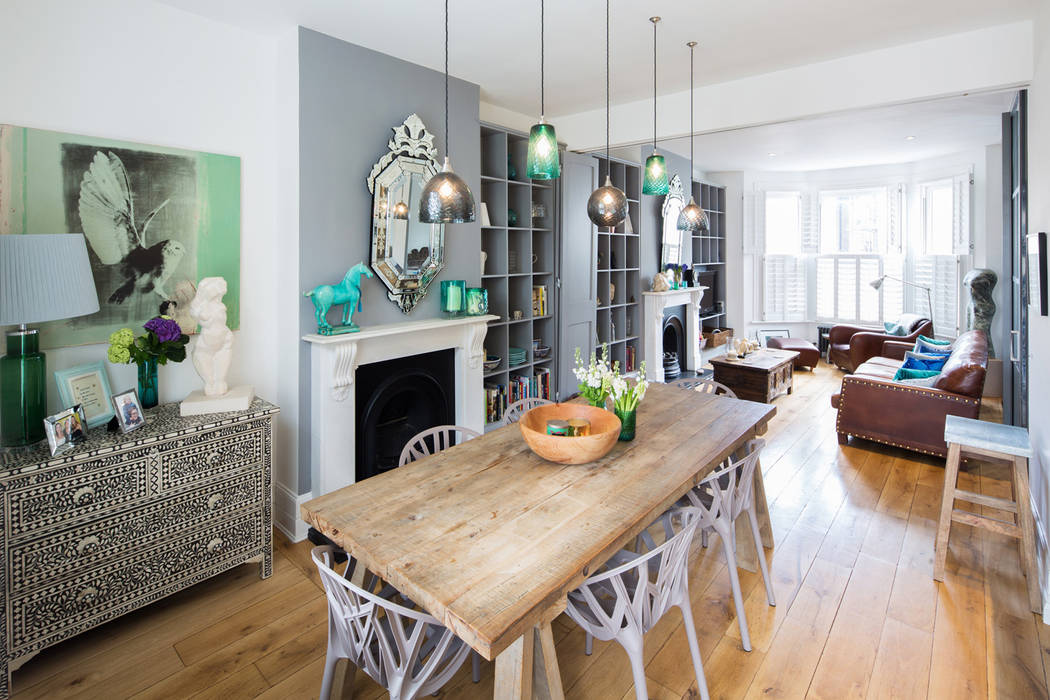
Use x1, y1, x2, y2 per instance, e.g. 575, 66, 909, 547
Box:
298, 27, 481, 494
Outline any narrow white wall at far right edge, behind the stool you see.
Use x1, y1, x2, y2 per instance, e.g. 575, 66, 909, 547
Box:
1028, 2, 1050, 621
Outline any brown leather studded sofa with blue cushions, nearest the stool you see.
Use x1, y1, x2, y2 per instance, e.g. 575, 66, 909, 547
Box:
832, 331, 988, 457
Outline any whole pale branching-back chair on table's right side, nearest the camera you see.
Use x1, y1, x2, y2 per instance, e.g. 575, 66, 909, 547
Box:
565, 508, 710, 700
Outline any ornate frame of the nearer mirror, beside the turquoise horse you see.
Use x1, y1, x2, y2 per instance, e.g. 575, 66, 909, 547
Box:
368, 113, 445, 314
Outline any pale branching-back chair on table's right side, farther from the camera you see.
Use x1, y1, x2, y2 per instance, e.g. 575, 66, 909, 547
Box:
680, 440, 777, 652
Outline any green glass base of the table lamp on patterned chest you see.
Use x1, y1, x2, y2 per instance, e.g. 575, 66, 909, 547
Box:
0, 326, 47, 449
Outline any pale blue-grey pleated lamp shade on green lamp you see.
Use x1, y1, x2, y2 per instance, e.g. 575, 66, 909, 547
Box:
0, 233, 99, 325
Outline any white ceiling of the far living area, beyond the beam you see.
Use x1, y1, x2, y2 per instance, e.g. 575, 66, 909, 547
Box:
641, 91, 1014, 172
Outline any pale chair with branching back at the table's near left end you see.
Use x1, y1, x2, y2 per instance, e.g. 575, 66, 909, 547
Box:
311, 545, 470, 700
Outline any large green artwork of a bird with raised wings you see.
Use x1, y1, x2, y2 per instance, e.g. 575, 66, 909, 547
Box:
0, 125, 240, 347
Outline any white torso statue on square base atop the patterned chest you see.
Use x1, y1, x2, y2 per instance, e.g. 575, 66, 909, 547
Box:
180, 277, 255, 416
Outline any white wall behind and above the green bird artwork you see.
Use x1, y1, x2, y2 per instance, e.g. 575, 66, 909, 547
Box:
0, 0, 298, 487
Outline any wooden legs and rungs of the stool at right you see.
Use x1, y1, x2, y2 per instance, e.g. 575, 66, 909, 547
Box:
933, 443, 1043, 614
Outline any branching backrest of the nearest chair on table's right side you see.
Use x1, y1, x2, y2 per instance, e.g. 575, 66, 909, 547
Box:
569, 508, 700, 639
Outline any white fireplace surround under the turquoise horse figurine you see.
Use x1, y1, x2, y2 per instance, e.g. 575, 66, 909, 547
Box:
300, 316, 498, 510
